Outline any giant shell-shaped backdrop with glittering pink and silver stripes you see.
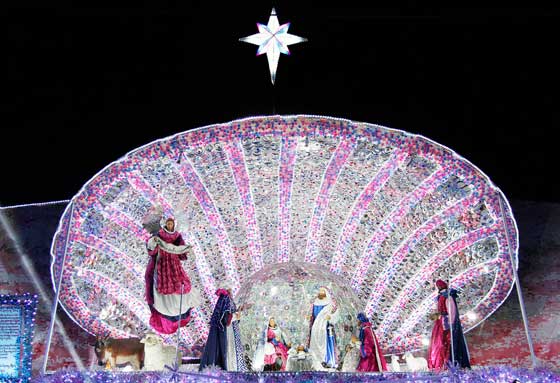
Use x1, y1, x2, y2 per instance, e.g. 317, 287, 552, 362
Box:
52, 115, 518, 357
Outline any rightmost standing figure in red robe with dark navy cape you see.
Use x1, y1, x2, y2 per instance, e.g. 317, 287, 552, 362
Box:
428, 279, 471, 371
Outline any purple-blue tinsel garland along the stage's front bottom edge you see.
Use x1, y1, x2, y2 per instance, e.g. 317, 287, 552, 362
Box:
32, 367, 560, 383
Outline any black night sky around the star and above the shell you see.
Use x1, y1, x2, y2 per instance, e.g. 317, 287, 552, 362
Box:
0, 0, 560, 206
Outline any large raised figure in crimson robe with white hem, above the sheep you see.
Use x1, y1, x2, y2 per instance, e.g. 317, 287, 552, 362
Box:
145, 218, 195, 334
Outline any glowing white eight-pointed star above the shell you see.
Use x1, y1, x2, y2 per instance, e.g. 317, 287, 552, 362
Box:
239, 8, 307, 85
